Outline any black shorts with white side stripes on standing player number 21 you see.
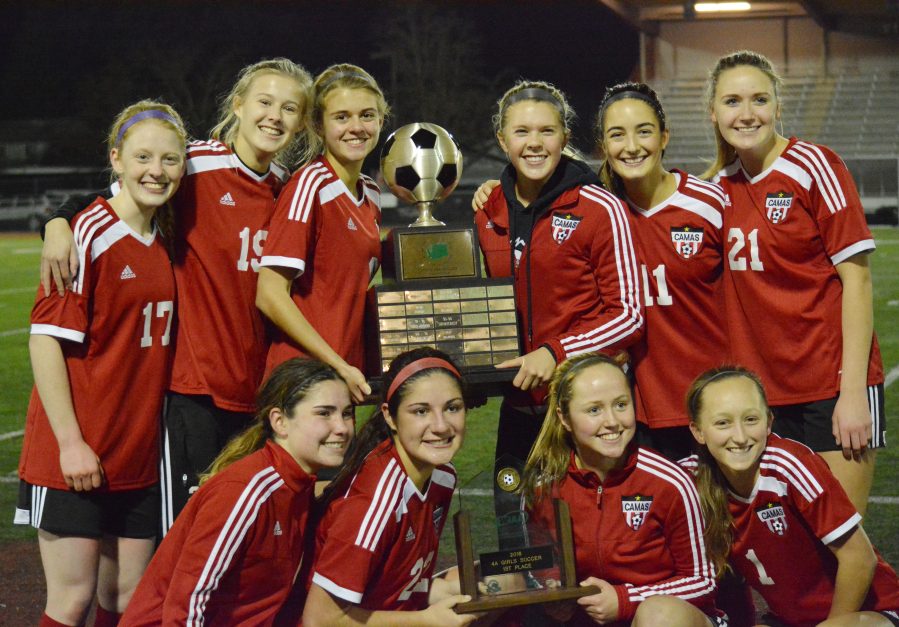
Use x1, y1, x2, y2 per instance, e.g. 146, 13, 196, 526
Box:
771, 383, 886, 453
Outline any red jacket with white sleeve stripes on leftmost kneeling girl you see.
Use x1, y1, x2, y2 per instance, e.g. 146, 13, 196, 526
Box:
120, 442, 315, 627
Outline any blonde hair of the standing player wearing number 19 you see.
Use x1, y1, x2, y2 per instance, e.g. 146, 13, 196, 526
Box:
210, 57, 315, 168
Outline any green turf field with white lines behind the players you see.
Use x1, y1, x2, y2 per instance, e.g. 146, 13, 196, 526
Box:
0, 229, 899, 565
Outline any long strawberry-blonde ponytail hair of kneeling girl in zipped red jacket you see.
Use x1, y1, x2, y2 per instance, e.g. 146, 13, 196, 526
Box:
521, 353, 630, 503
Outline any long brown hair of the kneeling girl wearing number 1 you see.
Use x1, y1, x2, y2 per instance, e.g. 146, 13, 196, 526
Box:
685, 366, 768, 578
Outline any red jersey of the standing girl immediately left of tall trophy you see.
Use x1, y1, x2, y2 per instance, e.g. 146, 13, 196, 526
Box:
262, 157, 381, 373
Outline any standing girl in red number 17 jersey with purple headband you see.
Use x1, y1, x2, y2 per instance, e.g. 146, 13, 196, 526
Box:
16, 100, 187, 627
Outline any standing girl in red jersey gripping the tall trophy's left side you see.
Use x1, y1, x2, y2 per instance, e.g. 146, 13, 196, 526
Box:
256, 64, 388, 401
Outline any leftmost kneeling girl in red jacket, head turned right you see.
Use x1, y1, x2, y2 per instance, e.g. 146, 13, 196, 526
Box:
120, 358, 354, 627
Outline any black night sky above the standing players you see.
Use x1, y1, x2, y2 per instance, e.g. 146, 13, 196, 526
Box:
0, 0, 638, 164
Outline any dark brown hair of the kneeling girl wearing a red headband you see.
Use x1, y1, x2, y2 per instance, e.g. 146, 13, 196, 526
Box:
321, 346, 469, 505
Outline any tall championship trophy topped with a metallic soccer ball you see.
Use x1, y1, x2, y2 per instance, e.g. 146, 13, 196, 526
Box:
369, 123, 520, 393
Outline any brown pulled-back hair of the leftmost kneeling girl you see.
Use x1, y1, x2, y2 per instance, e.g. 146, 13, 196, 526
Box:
200, 357, 345, 485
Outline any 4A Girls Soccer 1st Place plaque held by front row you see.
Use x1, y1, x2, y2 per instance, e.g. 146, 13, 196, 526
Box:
453, 456, 599, 614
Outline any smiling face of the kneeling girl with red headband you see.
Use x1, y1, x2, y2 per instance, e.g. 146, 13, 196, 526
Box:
381, 370, 465, 489
